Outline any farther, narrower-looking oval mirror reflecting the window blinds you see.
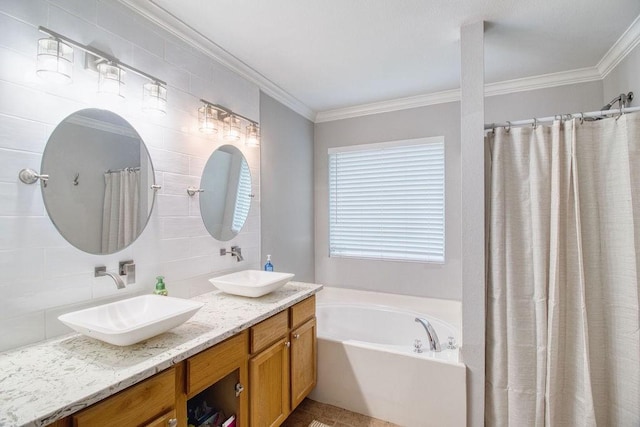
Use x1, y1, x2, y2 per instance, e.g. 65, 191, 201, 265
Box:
200, 145, 252, 242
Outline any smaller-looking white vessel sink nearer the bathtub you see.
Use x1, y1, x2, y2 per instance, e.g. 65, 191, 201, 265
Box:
209, 270, 294, 298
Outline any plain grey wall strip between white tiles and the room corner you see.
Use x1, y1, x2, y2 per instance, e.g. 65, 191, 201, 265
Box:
260, 93, 314, 282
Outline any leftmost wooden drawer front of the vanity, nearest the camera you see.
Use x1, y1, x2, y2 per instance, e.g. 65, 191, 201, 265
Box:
73, 368, 176, 427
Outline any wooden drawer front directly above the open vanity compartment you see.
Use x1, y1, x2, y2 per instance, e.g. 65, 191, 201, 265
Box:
187, 331, 247, 397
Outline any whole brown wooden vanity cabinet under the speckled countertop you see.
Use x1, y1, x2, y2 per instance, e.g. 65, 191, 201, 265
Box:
48, 296, 317, 427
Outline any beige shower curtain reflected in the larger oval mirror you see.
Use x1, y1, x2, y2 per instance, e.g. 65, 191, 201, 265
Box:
102, 168, 140, 253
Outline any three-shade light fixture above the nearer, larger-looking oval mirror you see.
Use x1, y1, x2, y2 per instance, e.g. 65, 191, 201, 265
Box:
37, 26, 167, 114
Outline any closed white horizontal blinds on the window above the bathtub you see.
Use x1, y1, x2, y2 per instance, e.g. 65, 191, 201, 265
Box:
329, 137, 444, 263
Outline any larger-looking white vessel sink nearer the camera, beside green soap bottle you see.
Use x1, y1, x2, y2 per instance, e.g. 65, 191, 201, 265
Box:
58, 295, 204, 346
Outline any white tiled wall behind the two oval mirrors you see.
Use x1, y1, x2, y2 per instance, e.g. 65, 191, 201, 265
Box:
0, 0, 260, 351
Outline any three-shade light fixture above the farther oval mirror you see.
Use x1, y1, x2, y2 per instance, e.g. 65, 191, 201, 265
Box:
198, 99, 260, 147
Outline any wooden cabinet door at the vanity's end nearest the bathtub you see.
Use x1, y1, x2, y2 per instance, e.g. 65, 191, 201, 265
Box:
291, 319, 318, 410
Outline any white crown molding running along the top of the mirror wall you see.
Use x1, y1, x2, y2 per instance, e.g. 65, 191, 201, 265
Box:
119, 0, 316, 121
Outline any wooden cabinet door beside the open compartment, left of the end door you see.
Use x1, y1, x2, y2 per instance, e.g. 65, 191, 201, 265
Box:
249, 338, 290, 427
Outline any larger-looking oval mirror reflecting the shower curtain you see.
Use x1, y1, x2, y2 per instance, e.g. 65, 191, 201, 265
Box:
40, 109, 155, 254
